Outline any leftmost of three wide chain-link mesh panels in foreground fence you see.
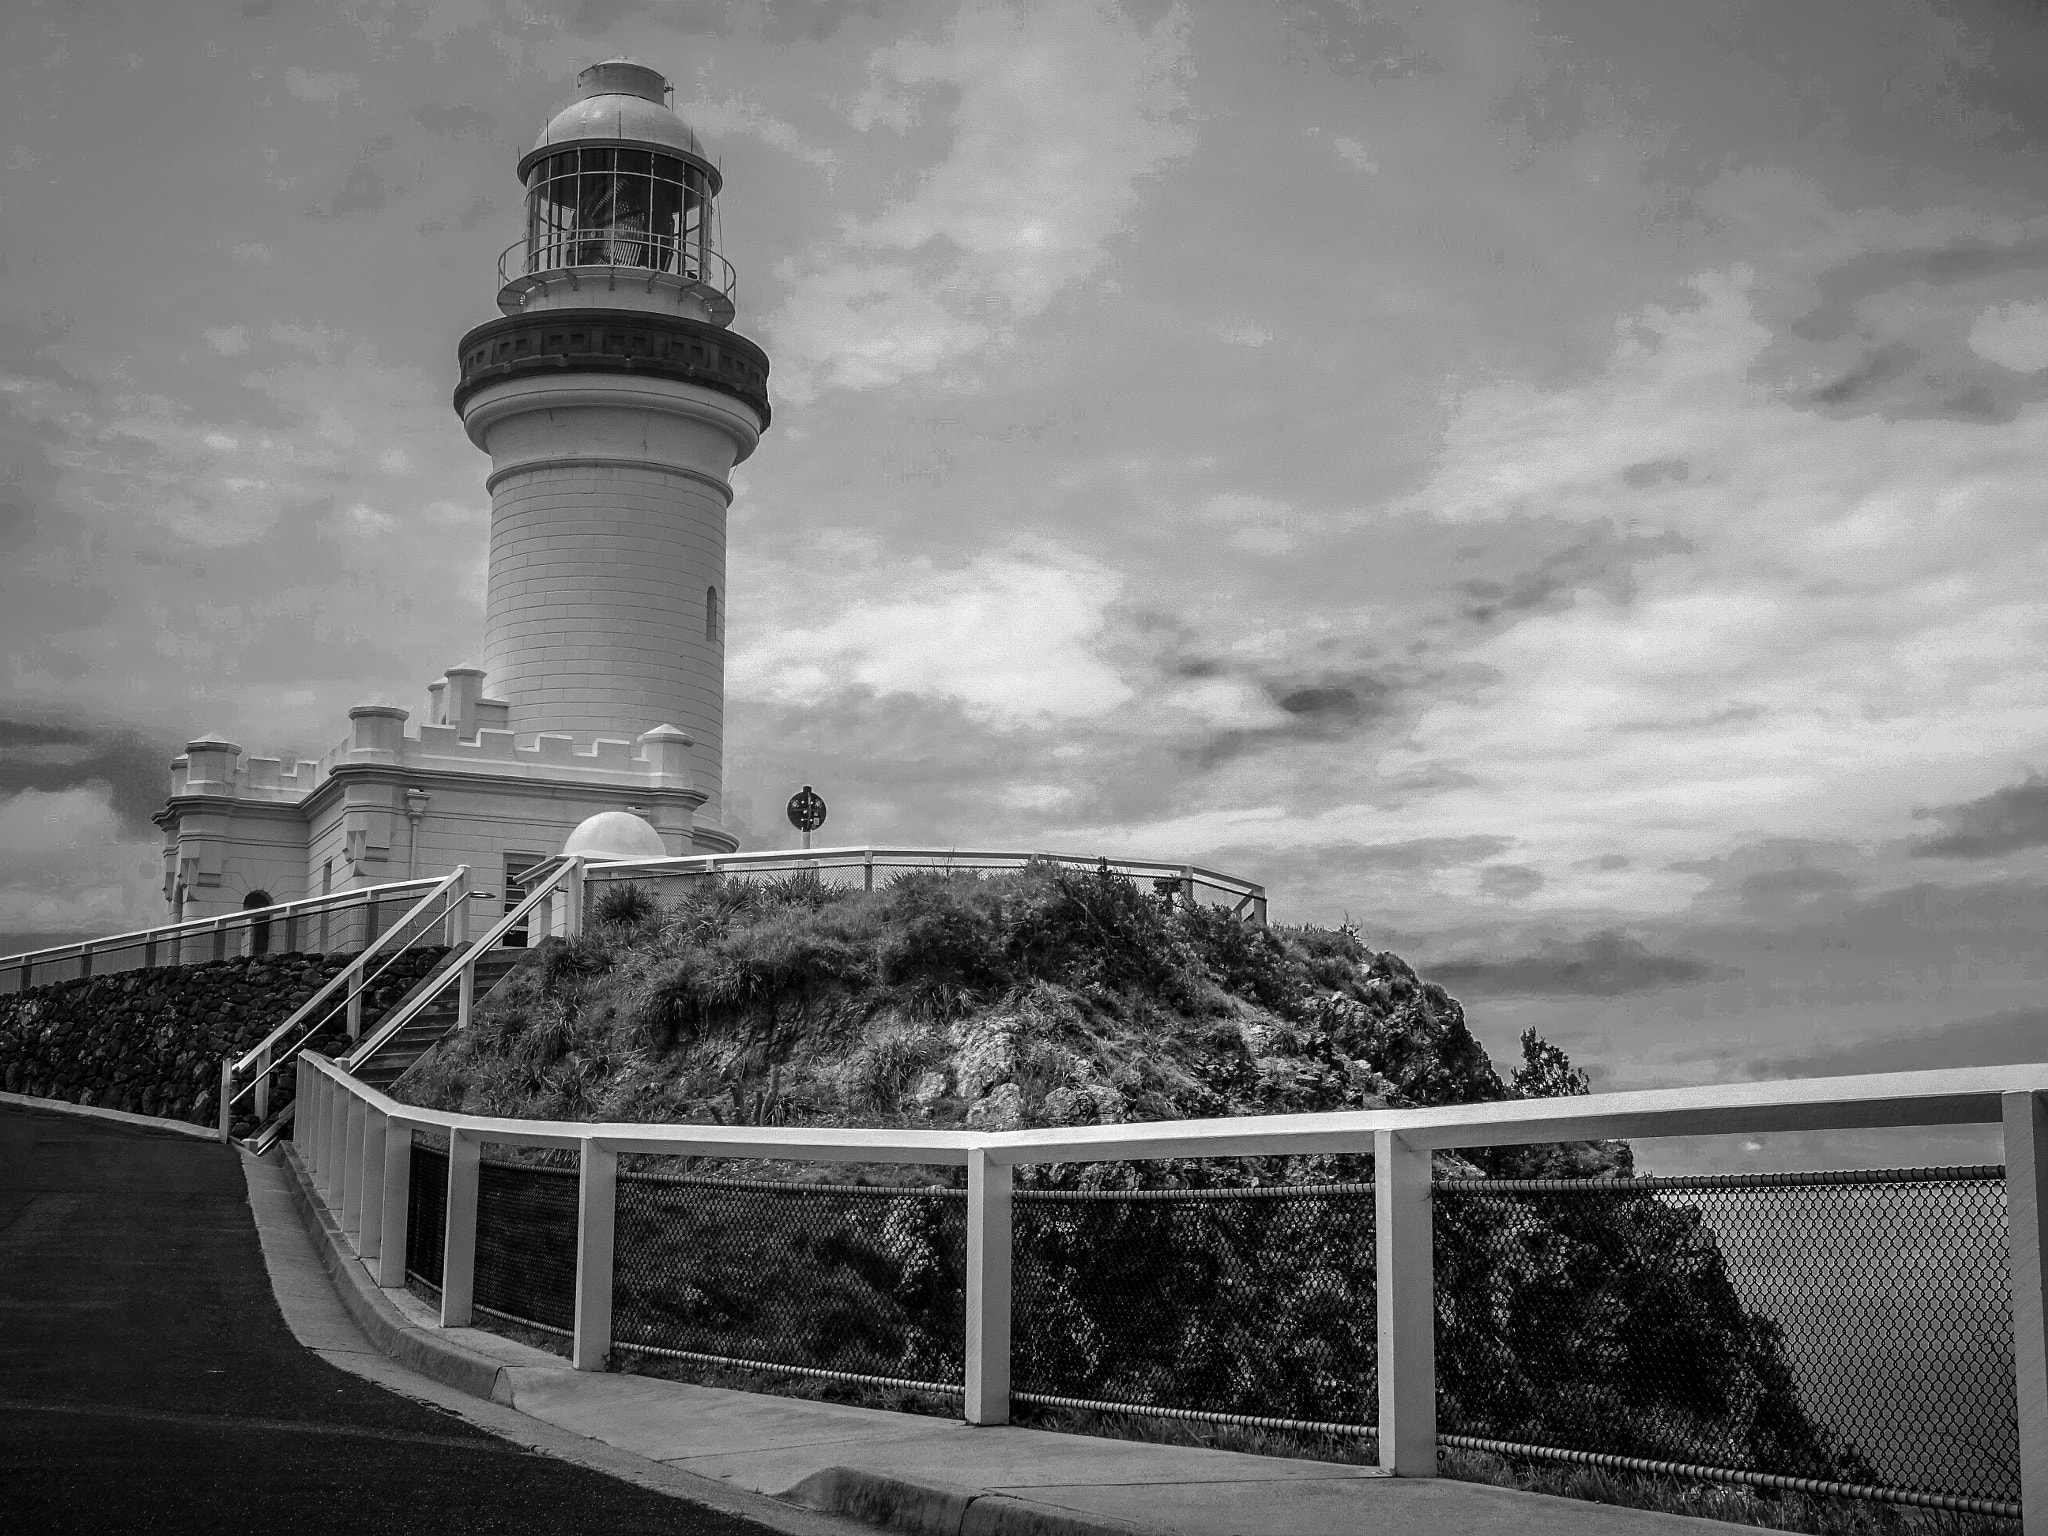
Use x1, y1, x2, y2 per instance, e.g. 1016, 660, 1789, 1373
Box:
612, 1174, 967, 1395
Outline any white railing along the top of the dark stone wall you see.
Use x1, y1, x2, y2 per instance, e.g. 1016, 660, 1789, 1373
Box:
0, 879, 468, 995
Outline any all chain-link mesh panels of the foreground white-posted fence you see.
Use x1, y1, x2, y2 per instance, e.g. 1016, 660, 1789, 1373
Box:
406, 1145, 2019, 1516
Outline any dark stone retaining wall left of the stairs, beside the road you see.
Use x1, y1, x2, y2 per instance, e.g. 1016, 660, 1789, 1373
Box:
0, 946, 446, 1135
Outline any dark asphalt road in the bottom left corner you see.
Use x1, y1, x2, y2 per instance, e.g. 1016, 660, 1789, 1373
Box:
0, 1106, 782, 1536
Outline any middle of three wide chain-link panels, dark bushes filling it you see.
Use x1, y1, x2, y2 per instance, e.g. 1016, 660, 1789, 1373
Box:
1010, 1184, 1378, 1438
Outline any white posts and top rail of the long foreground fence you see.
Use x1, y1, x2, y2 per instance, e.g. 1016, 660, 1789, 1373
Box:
293, 1053, 2048, 1536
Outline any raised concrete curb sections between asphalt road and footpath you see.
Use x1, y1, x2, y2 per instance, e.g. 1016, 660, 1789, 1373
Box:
276, 1138, 1139, 1536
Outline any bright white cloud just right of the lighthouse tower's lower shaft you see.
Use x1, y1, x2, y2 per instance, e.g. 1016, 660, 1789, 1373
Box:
729, 545, 1130, 729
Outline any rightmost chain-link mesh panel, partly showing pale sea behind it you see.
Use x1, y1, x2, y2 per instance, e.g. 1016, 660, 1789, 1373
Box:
1436, 1167, 2019, 1513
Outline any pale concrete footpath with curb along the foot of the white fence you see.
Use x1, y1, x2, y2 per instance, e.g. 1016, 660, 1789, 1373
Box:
260, 1114, 1755, 1536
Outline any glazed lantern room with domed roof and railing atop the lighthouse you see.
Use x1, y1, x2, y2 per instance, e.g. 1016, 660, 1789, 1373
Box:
498, 59, 735, 326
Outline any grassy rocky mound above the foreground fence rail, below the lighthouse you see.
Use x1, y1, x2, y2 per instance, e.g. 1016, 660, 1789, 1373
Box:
399, 866, 1626, 1174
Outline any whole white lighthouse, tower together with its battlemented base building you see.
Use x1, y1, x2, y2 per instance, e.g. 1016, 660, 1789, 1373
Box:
156, 59, 768, 918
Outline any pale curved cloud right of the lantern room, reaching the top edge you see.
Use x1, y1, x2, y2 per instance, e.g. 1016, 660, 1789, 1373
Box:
768, 0, 1194, 399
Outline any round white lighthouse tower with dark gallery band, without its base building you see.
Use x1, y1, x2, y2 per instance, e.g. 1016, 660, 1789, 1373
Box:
455, 59, 768, 823
